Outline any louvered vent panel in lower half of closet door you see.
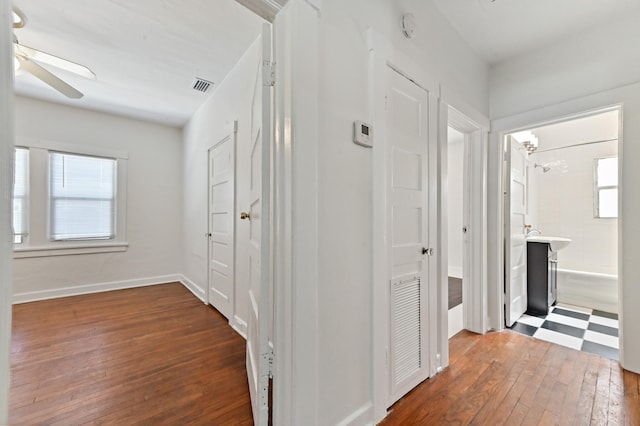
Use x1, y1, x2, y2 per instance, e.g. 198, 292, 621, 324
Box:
393, 279, 422, 385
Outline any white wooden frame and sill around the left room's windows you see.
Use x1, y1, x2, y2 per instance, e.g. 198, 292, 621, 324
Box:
13, 138, 129, 259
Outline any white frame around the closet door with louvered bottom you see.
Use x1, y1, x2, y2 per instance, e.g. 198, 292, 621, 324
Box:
367, 28, 448, 423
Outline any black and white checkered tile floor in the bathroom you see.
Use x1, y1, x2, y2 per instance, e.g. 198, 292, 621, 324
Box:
511, 305, 619, 360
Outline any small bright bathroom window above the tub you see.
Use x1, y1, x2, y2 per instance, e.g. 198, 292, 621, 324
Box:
594, 157, 618, 218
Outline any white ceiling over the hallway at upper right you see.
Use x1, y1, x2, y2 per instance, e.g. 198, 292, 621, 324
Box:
433, 0, 640, 64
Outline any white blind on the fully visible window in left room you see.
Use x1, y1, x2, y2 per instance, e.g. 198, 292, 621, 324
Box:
49, 152, 116, 241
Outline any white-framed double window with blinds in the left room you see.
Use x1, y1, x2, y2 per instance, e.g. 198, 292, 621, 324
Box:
13, 137, 129, 259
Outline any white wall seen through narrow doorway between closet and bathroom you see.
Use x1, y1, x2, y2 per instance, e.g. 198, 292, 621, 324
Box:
447, 127, 464, 278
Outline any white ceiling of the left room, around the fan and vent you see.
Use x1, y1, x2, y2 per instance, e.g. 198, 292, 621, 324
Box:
14, 0, 265, 127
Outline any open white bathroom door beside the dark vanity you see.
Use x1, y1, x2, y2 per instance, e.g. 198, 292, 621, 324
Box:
504, 136, 527, 327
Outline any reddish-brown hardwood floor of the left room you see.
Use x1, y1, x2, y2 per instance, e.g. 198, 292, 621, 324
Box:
9, 283, 252, 426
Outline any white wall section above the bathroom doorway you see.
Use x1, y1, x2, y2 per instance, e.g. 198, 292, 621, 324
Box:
490, 13, 640, 120
